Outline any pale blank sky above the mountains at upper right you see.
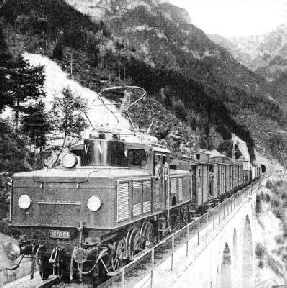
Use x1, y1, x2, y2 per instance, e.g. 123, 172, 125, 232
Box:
169, 0, 287, 37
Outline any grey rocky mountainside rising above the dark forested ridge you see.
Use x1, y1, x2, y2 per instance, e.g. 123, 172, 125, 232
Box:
67, 0, 264, 94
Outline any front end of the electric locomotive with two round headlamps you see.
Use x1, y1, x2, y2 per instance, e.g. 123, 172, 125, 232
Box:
11, 168, 114, 278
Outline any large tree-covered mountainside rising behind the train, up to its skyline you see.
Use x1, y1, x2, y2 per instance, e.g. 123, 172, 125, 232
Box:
0, 0, 285, 170
